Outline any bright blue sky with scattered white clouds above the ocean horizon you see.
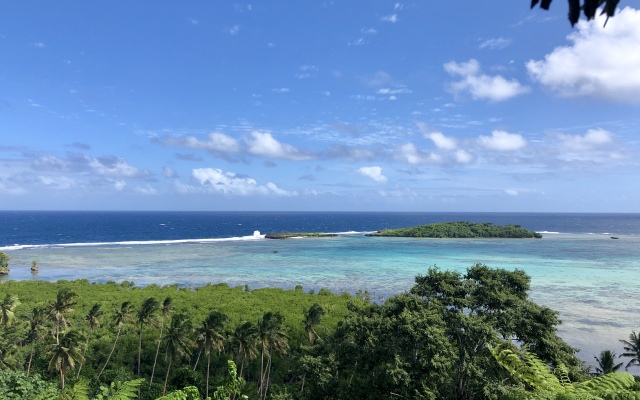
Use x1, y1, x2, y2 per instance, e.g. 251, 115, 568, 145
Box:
0, 0, 640, 212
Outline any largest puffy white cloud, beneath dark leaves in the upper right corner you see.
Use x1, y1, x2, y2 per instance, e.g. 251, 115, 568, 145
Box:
526, 7, 640, 103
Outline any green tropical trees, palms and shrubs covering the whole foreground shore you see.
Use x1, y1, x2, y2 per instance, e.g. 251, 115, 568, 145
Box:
0, 264, 640, 400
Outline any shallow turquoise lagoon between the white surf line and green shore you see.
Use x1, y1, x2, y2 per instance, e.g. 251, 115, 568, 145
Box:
0, 230, 640, 363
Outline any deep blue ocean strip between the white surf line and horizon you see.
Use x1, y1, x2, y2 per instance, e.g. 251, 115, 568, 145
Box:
0, 211, 640, 247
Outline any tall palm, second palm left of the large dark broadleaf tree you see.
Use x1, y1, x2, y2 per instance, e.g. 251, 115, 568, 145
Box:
258, 312, 289, 399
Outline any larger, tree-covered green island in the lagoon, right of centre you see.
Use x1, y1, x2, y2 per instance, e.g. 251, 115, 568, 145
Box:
367, 221, 542, 239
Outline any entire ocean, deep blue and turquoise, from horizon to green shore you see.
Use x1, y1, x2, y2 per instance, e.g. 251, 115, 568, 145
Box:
0, 211, 640, 363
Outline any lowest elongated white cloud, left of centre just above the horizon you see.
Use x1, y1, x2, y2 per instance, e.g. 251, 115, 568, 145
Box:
191, 168, 298, 196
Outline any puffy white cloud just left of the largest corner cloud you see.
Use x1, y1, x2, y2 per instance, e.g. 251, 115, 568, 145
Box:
444, 59, 530, 101
